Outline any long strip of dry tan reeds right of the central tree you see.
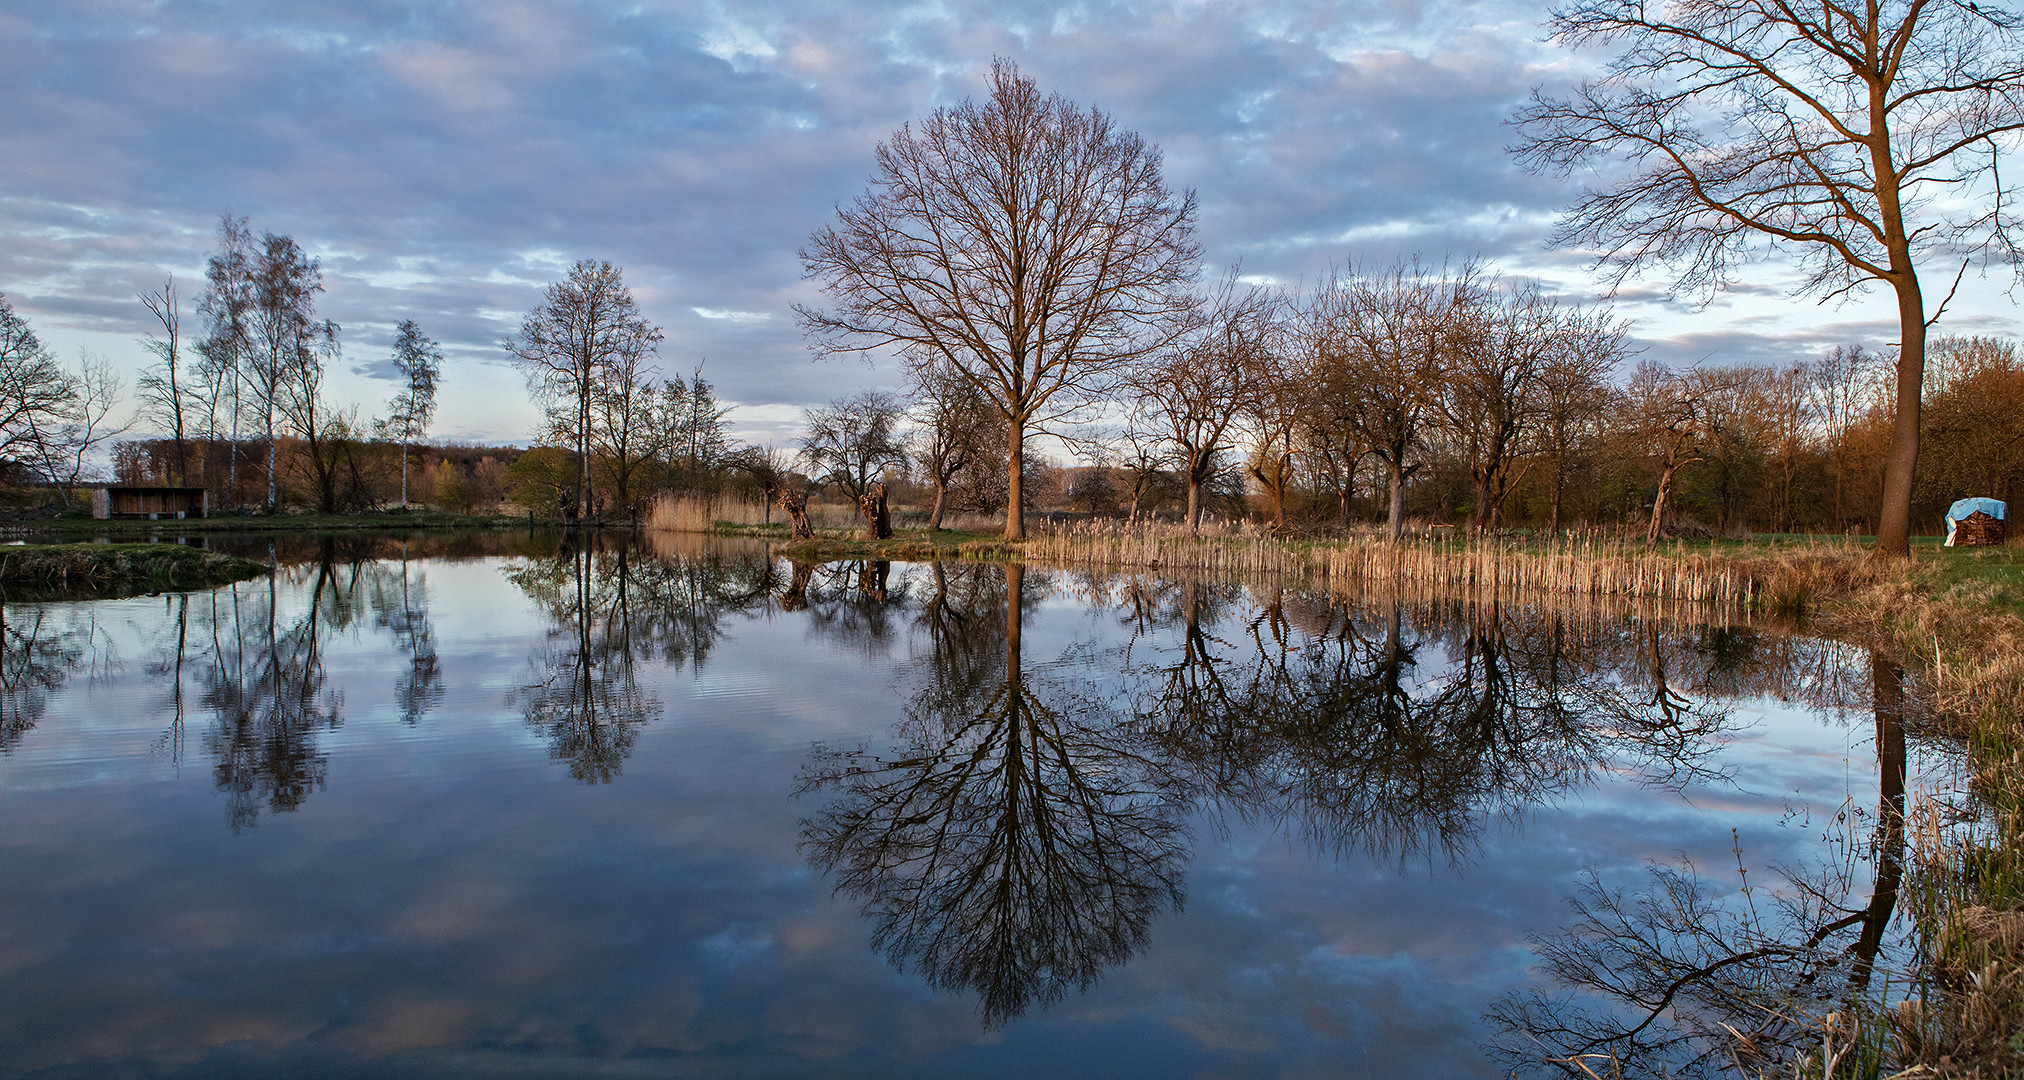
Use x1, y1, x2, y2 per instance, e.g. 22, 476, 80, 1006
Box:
1022, 522, 1880, 609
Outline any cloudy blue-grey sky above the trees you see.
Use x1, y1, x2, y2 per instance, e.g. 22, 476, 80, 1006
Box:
0, 0, 2024, 445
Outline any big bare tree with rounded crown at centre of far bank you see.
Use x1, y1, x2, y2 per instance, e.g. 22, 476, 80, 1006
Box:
795, 61, 1200, 538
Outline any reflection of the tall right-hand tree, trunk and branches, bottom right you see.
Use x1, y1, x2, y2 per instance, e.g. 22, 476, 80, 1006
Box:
1490, 657, 1907, 1076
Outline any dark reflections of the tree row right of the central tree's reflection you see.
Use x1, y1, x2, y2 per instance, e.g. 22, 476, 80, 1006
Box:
1140, 582, 1728, 860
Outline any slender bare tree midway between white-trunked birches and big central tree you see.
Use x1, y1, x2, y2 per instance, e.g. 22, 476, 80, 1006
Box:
504, 259, 662, 518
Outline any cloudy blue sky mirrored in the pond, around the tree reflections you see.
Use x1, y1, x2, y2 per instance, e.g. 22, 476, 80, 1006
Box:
0, 552, 1902, 1076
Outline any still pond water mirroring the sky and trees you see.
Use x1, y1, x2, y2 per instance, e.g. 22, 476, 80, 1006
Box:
0, 536, 1921, 1078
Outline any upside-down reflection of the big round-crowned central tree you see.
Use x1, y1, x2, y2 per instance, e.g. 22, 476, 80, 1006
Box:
804, 566, 1186, 1023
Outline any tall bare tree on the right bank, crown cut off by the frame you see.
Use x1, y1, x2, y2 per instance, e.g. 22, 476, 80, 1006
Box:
1518, 0, 2024, 558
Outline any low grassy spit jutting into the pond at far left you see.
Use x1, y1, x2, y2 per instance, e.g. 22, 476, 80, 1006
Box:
0, 544, 267, 601
